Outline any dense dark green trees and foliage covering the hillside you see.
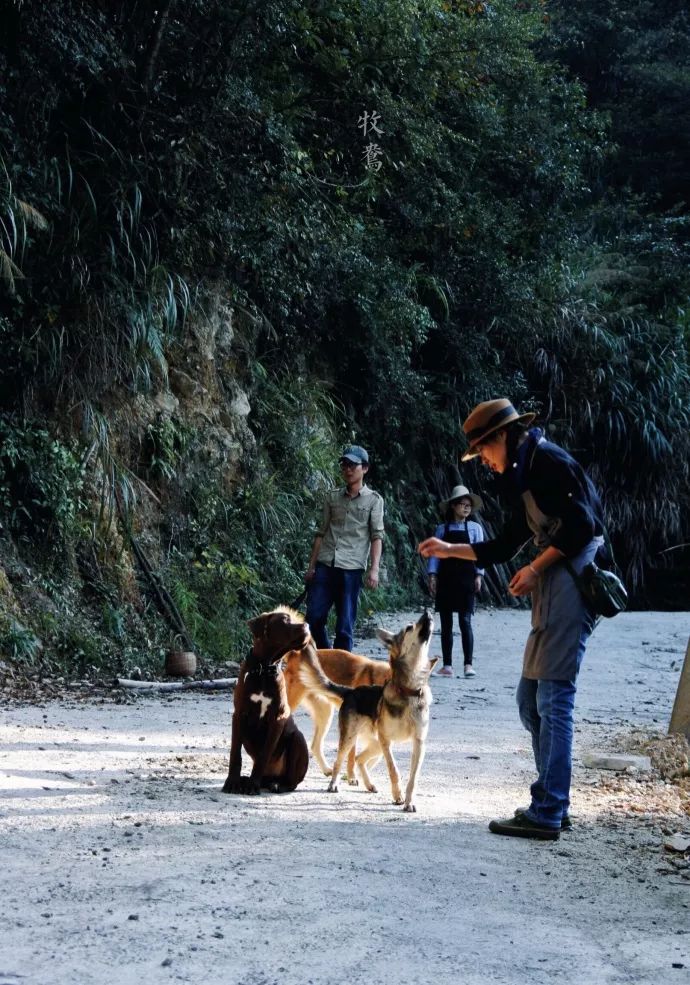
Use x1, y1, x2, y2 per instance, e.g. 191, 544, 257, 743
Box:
0, 0, 690, 668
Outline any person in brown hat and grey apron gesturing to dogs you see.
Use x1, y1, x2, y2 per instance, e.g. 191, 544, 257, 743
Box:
419, 399, 604, 840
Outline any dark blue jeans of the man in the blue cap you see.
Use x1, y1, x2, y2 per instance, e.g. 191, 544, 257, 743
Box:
307, 563, 364, 650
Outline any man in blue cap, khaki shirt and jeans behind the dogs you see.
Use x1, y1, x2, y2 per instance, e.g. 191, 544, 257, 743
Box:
304, 445, 383, 650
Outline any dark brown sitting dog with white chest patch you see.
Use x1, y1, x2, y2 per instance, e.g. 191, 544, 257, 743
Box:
223, 606, 344, 794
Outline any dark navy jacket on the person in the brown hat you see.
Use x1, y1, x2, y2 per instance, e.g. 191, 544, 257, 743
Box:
472, 428, 604, 565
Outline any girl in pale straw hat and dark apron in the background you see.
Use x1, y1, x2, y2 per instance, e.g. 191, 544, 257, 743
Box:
428, 486, 484, 677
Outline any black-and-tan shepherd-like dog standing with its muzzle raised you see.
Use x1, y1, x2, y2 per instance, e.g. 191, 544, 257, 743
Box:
300, 610, 438, 812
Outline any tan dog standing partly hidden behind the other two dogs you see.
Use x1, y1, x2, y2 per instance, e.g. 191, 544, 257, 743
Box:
283, 650, 391, 776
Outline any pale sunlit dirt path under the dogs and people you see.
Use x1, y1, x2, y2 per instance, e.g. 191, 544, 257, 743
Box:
0, 611, 690, 985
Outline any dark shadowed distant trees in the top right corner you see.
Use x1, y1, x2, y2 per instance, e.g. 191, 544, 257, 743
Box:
550, 0, 690, 214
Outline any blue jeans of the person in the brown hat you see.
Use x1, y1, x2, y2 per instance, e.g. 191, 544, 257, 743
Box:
517, 616, 594, 829
